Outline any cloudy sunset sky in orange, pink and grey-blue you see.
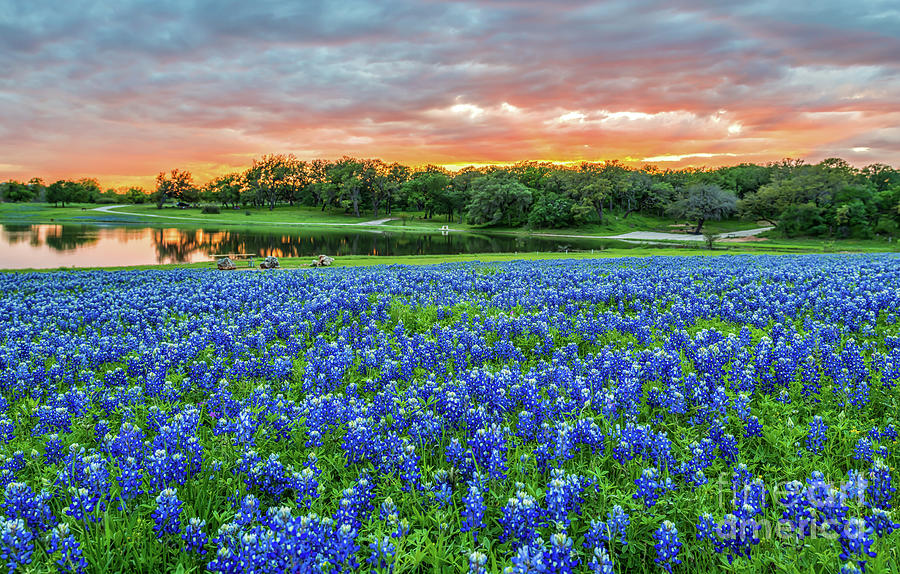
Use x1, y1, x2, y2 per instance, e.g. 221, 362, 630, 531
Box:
0, 0, 900, 188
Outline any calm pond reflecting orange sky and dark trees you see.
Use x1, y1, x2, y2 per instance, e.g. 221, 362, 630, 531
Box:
0, 224, 621, 269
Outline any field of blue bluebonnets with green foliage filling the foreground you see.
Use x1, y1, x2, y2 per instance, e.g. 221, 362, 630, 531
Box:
0, 256, 900, 573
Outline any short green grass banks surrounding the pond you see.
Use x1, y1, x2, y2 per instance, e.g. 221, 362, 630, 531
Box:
0, 203, 900, 273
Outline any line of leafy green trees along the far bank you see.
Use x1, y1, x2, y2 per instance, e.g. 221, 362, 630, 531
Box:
0, 154, 900, 238
